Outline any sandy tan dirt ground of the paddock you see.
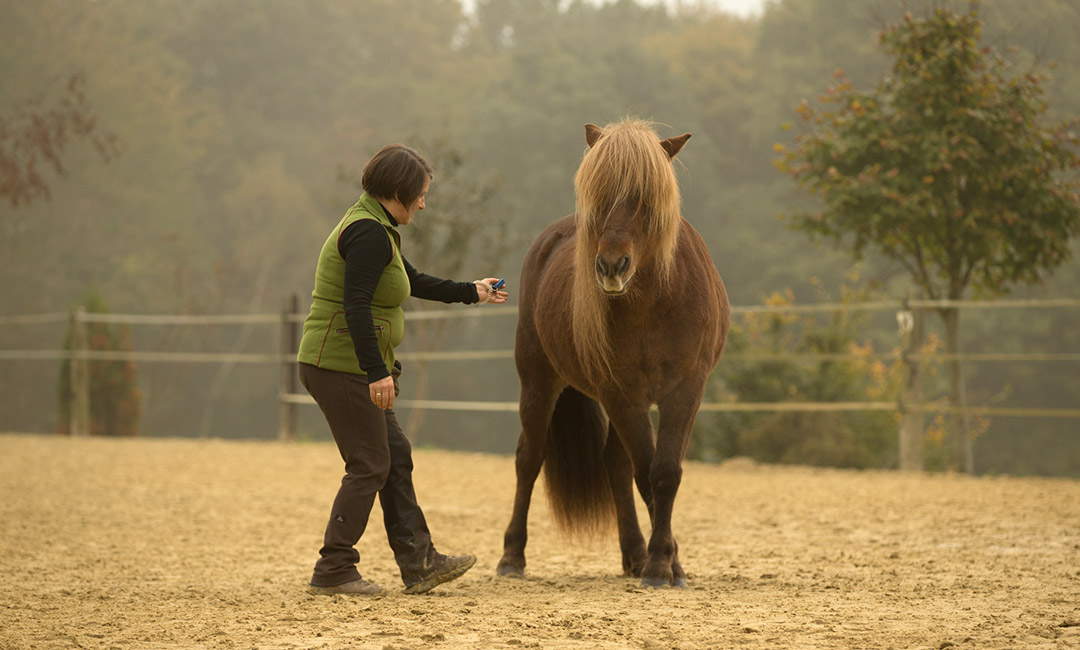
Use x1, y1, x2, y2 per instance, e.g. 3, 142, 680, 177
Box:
0, 434, 1080, 650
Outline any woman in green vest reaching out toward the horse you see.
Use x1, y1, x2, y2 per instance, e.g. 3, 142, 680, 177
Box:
297, 145, 508, 595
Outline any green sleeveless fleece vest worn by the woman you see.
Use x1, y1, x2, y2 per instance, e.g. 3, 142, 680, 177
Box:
296, 192, 411, 375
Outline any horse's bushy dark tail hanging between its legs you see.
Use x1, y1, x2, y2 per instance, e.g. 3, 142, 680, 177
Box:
543, 388, 615, 536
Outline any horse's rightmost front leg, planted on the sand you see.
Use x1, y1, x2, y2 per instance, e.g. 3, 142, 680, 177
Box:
642, 387, 702, 588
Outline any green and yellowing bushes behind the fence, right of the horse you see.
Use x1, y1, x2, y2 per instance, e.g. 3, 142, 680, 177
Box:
693, 273, 900, 468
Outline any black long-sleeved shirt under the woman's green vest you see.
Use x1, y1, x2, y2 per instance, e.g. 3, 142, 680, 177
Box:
338, 208, 480, 382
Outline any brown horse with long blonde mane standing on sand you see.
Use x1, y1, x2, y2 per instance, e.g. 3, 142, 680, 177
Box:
498, 120, 730, 587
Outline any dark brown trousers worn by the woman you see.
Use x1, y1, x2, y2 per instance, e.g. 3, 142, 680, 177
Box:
299, 363, 435, 586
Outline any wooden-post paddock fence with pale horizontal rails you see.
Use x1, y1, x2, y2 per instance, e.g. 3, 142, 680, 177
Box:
0, 296, 1080, 468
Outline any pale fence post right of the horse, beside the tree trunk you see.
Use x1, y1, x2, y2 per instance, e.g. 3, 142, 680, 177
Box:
896, 298, 924, 472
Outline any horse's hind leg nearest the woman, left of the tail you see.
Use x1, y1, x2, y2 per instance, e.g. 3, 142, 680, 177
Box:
498, 382, 559, 577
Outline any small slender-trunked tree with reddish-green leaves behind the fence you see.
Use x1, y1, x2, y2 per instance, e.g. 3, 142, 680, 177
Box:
779, 3, 1080, 472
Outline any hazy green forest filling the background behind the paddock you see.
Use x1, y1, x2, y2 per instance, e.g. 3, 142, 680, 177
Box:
0, 0, 1080, 473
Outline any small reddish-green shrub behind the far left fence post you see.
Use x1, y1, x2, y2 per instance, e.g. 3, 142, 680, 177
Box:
56, 292, 141, 435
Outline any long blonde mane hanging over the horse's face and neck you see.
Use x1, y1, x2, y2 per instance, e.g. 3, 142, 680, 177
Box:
571, 119, 681, 380
